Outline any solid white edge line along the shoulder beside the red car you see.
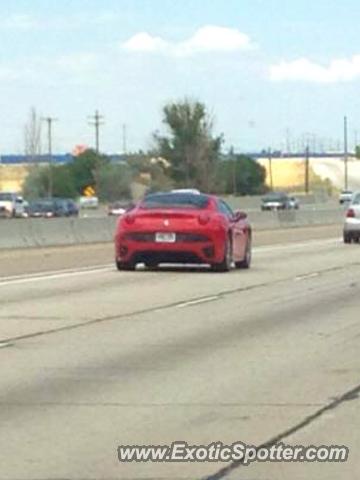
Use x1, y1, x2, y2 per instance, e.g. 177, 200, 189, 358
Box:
0, 238, 340, 288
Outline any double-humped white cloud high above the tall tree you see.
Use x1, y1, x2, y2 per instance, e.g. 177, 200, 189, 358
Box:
121, 25, 253, 56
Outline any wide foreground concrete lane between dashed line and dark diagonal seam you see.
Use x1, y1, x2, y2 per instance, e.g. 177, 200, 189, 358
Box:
0, 267, 360, 479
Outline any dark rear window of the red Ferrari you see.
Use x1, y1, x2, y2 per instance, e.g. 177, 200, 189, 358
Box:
140, 193, 209, 210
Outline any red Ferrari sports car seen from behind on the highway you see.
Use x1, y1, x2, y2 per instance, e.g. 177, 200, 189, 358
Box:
115, 192, 251, 272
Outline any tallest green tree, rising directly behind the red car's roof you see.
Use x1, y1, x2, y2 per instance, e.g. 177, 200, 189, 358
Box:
155, 99, 222, 191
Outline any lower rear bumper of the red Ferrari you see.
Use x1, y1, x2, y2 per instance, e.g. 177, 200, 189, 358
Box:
115, 232, 225, 263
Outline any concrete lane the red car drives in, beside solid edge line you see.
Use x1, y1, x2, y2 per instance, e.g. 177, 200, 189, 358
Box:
0, 240, 358, 340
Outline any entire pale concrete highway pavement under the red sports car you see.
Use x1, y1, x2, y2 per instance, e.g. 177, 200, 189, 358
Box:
0, 227, 360, 480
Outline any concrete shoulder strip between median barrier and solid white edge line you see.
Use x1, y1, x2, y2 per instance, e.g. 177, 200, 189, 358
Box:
0, 225, 342, 278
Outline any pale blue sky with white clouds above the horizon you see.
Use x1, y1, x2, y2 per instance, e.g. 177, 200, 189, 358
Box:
0, 0, 360, 154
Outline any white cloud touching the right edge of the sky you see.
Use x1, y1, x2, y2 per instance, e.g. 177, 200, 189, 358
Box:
270, 55, 360, 83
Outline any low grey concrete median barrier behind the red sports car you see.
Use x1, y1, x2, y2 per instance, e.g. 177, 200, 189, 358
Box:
0, 210, 344, 249
